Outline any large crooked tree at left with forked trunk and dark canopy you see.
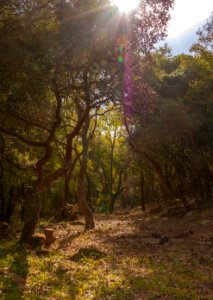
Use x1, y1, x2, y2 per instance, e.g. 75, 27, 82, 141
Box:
1, 1, 122, 241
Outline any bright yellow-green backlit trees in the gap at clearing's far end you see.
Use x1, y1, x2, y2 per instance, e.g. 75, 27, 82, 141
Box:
89, 107, 129, 213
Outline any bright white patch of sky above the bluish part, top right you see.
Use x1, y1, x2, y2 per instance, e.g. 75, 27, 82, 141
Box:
168, 0, 213, 38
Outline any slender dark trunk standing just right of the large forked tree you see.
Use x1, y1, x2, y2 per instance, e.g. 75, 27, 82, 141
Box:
78, 119, 95, 230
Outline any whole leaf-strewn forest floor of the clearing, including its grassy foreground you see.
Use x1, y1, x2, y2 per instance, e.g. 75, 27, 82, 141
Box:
0, 209, 213, 300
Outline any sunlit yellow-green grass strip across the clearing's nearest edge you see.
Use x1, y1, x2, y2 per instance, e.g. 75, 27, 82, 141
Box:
0, 242, 210, 300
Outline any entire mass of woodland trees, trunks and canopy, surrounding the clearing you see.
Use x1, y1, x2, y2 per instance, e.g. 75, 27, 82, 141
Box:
0, 0, 213, 242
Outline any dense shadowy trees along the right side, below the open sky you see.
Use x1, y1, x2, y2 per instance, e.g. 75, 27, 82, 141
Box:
126, 17, 213, 208
